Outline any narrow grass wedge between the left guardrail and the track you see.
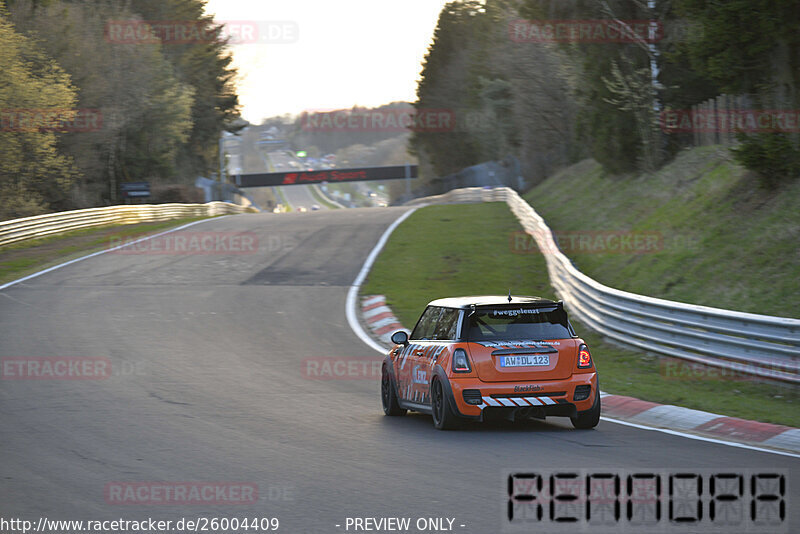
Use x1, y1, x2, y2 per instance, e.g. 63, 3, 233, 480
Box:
0, 217, 207, 283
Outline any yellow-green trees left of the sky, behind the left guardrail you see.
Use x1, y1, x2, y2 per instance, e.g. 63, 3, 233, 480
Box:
0, 0, 239, 220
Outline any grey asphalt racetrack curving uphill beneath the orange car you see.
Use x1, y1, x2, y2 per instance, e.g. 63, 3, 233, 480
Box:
0, 208, 800, 534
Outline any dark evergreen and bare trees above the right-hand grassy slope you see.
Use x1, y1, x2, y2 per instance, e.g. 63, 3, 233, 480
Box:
412, 0, 800, 188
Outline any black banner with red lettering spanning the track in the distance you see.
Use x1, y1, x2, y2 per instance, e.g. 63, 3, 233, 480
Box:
236, 165, 417, 187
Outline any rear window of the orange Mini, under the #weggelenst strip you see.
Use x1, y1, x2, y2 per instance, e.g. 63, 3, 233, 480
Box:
467, 307, 572, 341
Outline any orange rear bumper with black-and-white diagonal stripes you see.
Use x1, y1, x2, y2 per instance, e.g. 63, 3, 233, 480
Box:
449, 372, 597, 419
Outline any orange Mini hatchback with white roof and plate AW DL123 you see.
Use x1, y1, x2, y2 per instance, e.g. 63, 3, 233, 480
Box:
381, 296, 600, 430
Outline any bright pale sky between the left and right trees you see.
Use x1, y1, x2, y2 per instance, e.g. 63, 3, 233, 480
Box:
206, 0, 446, 122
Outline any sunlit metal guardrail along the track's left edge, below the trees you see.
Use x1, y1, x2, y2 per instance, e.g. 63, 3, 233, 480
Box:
0, 202, 257, 247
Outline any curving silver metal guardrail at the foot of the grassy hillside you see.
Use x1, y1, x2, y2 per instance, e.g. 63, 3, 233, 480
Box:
406, 187, 800, 384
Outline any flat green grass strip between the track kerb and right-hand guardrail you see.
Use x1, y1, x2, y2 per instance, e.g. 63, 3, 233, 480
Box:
361, 203, 800, 427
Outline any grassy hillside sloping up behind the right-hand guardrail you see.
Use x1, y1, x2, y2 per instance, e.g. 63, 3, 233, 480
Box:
524, 147, 800, 317
